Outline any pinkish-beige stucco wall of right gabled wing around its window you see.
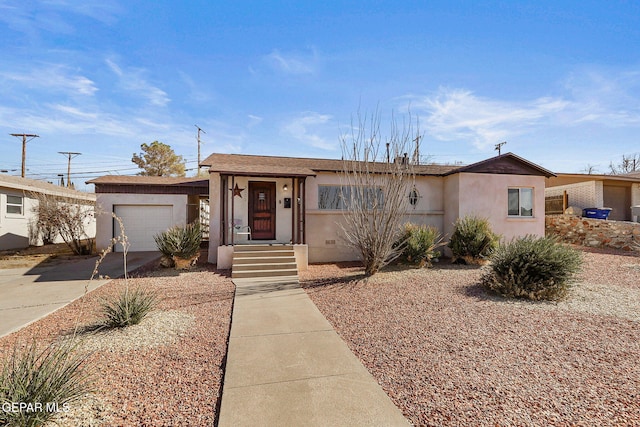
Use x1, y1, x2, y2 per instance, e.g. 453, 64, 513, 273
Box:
445, 173, 545, 241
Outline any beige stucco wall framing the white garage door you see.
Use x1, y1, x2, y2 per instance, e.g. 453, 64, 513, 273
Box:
96, 193, 187, 251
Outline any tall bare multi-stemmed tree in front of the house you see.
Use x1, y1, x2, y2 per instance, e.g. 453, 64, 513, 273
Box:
340, 113, 419, 276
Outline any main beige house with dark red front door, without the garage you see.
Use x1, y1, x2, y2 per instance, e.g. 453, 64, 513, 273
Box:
201, 153, 554, 268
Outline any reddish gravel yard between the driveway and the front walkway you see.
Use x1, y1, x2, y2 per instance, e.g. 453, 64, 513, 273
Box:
0, 256, 234, 426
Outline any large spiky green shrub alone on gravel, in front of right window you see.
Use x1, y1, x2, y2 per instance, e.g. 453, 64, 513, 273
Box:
482, 236, 582, 300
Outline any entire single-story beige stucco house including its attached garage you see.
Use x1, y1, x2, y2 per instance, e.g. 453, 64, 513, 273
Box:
88, 153, 555, 268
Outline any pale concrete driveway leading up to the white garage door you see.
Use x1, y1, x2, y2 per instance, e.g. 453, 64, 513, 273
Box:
0, 252, 160, 337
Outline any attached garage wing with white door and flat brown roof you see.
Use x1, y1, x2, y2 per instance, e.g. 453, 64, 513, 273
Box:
87, 175, 209, 251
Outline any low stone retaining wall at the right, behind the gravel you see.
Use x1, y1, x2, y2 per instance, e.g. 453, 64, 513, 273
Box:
545, 215, 640, 251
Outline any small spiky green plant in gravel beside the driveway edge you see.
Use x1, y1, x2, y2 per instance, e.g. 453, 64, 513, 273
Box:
101, 287, 158, 328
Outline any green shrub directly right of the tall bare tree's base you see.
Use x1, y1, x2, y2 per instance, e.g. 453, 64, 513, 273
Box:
396, 223, 444, 267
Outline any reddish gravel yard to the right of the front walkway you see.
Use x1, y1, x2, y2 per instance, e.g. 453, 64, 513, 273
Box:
301, 250, 640, 426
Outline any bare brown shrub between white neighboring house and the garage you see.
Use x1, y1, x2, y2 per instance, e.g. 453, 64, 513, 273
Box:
31, 193, 95, 255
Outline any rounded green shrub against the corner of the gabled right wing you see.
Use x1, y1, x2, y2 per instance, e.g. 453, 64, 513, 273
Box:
449, 216, 500, 264
